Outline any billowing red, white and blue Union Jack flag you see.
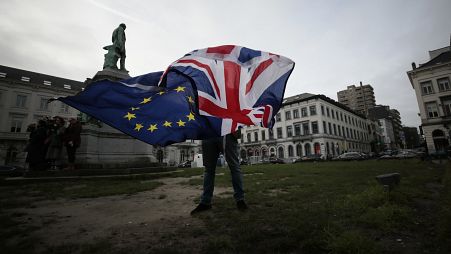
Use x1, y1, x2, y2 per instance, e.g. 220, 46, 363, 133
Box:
161, 45, 294, 136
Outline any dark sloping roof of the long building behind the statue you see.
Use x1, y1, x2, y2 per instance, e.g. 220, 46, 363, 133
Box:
0, 65, 85, 91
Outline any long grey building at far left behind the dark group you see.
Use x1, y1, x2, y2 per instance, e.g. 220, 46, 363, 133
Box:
0, 65, 84, 165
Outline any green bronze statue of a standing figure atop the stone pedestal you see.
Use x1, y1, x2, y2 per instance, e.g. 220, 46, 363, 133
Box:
103, 23, 127, 71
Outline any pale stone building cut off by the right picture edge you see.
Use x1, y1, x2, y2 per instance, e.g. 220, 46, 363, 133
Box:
407, 43, 451, 153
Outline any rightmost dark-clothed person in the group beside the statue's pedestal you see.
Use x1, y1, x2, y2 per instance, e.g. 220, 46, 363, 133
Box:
64, 118, 81, 170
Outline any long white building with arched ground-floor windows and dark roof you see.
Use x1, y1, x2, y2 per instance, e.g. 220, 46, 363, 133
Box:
240, 93, 371, 160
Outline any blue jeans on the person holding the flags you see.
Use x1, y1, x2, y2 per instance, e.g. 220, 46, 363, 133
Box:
200, 134, 244, 205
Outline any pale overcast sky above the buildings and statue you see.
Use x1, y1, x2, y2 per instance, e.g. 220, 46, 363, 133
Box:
0, 0, 451, 127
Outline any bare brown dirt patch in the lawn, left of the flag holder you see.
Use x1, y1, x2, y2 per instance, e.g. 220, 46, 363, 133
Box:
13, 178, 231, 253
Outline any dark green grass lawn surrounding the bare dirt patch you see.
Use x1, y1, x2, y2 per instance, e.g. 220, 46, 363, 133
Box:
0, 160, 451, 254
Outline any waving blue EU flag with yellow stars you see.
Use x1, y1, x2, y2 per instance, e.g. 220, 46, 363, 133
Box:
58, 72, 219, 146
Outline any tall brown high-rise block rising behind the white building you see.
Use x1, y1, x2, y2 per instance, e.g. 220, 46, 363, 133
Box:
337, 82, 376, 115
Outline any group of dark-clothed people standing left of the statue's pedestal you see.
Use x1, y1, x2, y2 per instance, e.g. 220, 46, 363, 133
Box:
26, 116, 81, 170
